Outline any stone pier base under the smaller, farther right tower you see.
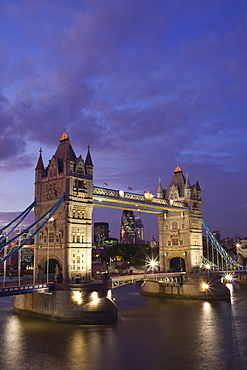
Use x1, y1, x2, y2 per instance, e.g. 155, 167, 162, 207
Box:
141, 273, 230, 300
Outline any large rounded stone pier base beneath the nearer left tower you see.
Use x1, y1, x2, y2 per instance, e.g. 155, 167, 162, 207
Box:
14, 282, 118, 324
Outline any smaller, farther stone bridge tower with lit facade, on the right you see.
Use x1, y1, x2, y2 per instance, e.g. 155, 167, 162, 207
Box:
157, 167, 203, 272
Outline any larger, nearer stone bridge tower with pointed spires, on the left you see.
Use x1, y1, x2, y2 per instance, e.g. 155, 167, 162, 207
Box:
35, 132, 93, 283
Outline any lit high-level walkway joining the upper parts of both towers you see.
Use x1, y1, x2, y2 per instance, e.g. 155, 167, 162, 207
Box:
93, 186, 189, 214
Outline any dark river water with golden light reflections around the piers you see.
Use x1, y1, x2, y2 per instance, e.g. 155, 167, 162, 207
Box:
0, 283, 247, 370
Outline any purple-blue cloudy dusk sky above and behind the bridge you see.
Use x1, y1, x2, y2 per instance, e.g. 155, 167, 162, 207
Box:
0, 0, 247, 240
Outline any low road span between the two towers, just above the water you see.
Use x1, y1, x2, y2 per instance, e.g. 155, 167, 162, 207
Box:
111, 272, 186, 288
